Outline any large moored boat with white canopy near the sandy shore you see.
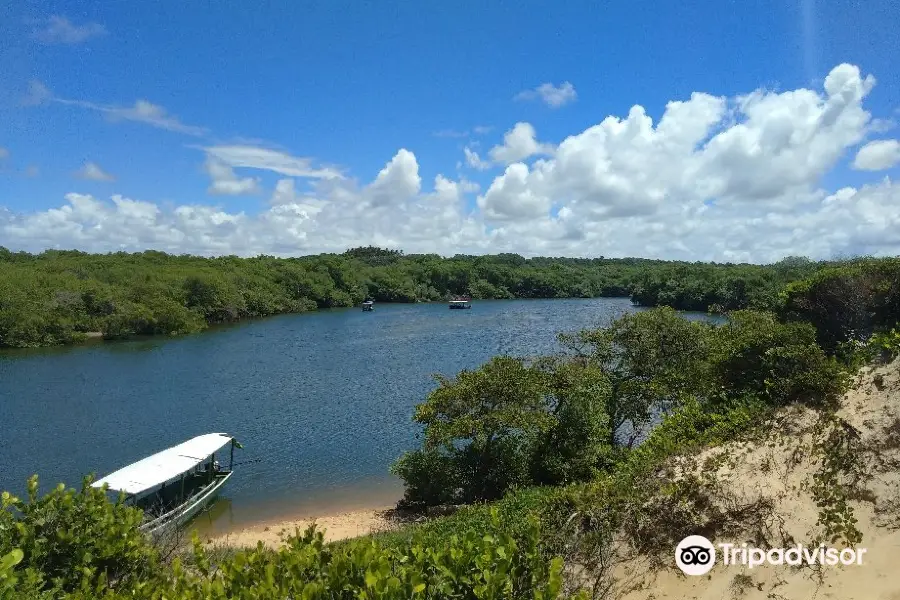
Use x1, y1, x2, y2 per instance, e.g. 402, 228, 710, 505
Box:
91, 433, 242, 534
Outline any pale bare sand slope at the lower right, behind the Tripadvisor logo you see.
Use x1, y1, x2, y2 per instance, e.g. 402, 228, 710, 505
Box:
620, 361, 900, 600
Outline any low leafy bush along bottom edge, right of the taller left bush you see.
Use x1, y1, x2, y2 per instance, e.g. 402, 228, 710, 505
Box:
175, 517, 562, 600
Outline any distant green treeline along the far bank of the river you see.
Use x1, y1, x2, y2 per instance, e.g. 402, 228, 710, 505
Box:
0, 247, 844, 347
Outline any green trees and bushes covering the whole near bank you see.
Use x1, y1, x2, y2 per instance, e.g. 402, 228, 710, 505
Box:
0, 255, 900, 600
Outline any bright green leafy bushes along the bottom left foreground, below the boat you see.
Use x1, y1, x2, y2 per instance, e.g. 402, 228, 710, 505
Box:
0, 490, 576, 600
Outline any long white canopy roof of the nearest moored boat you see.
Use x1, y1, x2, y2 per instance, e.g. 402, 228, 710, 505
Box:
91, 433, 232, 494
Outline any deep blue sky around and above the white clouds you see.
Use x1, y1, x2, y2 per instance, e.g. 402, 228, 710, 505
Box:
0, 0, 900, 258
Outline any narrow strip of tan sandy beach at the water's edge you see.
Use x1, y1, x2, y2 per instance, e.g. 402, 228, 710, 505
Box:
207, 506, 396, 548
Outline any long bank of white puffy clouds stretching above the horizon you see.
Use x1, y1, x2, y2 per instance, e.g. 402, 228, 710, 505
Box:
0, 64, 900, 262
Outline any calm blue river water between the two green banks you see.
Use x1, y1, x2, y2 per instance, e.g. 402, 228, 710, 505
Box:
0, 298, 700, 530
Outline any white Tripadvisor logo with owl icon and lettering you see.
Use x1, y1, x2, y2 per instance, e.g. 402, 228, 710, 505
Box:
675, 535, 866, 575
